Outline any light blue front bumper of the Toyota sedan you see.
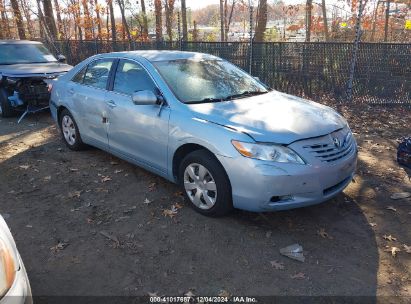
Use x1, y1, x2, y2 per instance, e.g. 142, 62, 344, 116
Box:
218, 148, 357, 212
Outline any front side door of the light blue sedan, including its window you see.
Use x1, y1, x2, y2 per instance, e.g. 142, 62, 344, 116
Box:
106, 59, 170, 173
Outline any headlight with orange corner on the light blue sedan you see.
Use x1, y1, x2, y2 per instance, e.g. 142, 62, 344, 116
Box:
231, 140, 305, 164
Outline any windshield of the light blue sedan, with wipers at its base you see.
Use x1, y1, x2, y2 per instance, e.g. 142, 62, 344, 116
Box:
153, 59, 269, 103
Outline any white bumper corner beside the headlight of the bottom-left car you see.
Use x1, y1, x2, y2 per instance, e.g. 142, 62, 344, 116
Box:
0, 255, 33, 304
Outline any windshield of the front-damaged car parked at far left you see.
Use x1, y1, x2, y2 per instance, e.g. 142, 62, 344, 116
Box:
0, 43, 57, 65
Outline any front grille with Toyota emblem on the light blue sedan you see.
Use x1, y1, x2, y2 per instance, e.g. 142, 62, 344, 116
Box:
303, 131, 354, 163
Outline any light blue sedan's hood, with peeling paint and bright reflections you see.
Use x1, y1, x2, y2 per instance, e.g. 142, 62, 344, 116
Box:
188, 91, 347, 144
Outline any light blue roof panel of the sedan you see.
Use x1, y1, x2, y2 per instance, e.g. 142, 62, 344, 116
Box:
103, 50, 221, 62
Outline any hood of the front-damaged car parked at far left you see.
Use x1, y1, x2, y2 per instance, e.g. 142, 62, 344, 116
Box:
0, 62, 72, 77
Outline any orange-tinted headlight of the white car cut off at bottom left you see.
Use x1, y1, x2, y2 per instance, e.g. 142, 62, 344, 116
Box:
0, 239, 16, 297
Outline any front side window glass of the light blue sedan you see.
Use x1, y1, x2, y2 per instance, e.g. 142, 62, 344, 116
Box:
113, 60, 156, 95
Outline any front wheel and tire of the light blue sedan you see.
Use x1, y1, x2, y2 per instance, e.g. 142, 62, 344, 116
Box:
178, 150, 233, 217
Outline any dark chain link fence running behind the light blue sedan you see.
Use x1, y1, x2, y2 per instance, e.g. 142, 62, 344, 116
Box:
49, 40, 411, 105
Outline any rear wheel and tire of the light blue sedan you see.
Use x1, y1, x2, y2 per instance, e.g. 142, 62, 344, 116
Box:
59, 109, 85, 151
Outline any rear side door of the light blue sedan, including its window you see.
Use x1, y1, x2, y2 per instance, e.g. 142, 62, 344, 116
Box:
69, 59, 115, 149
